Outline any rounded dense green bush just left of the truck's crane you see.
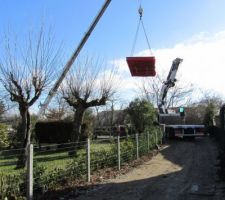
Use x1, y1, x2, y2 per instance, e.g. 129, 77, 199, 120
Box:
127, 99, 156, 133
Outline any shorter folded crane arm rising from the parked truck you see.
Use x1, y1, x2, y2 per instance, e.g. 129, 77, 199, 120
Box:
158, 58, 183, 114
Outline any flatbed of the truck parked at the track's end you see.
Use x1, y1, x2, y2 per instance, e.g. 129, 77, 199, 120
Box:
165, 124, 206, 138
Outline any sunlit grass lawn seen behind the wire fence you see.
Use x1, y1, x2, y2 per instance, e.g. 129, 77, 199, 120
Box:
0, 138, 156, 175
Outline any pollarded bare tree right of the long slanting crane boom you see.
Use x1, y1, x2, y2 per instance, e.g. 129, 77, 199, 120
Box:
62, 57, 116, 141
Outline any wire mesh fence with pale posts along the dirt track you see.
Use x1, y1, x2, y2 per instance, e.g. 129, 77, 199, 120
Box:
0, 130, 162, 199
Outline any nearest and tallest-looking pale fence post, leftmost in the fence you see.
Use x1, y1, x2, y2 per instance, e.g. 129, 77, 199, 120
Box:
27, 144, 33, 200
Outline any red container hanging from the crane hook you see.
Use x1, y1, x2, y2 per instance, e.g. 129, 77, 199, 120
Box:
127, 57, 156, 76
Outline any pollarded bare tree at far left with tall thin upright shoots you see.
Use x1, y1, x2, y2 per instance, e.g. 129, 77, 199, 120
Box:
0, 26, 59, 164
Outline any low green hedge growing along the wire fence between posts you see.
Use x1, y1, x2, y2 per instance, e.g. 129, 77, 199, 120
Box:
0, 131, 161, 199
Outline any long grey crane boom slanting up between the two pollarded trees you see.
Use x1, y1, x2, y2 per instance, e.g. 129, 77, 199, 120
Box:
38, 0, 111, 118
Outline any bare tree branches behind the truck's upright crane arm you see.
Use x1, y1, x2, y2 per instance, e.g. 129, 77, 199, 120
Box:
140, 74, 193, 108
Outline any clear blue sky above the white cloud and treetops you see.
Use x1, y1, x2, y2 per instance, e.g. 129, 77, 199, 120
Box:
0, 0, 225, 58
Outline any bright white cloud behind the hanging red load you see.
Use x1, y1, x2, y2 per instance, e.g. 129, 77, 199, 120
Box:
114, 31, 225, 101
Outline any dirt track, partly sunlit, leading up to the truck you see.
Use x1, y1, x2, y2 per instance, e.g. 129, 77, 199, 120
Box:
76, 138, 225, 200
